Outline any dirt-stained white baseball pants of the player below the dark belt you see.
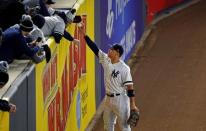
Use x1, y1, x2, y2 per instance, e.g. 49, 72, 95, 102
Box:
103, 94, 131, 131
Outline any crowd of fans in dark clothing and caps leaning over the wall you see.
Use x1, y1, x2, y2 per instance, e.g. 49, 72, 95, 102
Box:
0, 0, 81, 112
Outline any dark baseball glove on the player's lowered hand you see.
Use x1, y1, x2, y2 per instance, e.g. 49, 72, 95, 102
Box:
127, 110, 140, 127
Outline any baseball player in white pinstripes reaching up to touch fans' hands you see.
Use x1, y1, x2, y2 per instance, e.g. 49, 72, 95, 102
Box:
80, 29, 139, 131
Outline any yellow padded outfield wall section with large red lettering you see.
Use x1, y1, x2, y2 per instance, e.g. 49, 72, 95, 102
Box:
36, 0, 96, 131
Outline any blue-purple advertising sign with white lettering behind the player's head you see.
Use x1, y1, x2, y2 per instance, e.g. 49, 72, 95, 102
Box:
100, 0, 144, 60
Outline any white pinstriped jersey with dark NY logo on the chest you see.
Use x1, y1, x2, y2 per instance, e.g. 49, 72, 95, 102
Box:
98, 50, 133, 93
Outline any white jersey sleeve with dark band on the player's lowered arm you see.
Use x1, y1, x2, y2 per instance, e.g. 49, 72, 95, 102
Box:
123, 68, 133, 86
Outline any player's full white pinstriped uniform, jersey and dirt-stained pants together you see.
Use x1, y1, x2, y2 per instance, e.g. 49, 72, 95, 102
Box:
98, 50, 133, 131
